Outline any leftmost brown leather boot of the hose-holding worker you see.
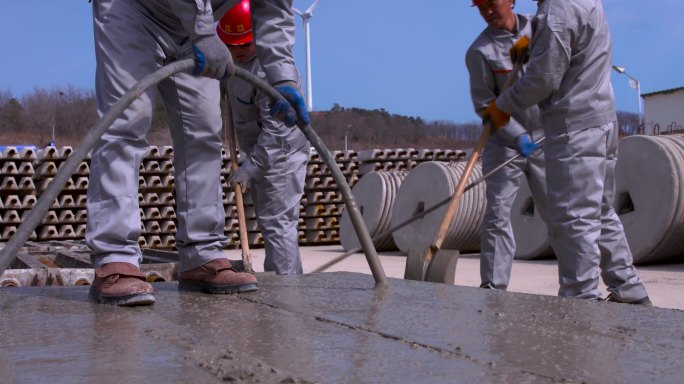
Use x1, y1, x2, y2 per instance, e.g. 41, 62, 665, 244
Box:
89, 263, 154, 307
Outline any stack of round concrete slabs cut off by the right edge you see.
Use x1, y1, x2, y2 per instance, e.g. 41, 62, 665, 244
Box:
614, 135, 684, 264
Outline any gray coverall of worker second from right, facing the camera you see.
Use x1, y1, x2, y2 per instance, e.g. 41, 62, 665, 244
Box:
466, 15, 546, 289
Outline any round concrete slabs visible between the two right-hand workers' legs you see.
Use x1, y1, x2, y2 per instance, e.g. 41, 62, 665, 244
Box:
511, 176, 554, 260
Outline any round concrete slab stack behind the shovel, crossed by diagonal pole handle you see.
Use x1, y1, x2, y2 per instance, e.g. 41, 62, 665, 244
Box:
392, 162, 486, 253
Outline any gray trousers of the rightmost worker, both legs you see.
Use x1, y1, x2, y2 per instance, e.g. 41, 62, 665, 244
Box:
544, 123, 647, 301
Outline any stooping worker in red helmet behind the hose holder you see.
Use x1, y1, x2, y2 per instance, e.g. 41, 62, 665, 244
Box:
216, 0, 309, 275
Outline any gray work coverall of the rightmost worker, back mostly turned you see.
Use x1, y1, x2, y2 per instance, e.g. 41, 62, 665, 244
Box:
497, 0, 647, 302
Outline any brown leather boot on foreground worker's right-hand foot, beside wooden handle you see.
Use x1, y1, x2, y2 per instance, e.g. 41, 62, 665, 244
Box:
178, 259, 257, 293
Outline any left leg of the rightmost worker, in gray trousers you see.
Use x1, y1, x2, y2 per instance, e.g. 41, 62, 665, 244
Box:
544, 127, 606, 299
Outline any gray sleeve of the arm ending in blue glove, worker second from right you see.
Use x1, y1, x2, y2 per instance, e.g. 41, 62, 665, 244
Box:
466, 50, 527, 145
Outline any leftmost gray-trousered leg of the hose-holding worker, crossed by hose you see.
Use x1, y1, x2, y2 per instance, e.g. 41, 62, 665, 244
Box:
86, 0, 160, 268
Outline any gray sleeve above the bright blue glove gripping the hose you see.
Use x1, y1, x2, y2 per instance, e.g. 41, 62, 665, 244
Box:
251, 0, 299, 84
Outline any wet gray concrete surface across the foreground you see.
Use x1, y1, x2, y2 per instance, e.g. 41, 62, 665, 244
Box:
0, 272, 684, 384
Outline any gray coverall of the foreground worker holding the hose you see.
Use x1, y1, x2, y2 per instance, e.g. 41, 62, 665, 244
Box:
86, 0, 296, 272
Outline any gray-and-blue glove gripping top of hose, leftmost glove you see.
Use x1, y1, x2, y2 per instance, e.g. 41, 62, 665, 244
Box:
192, 34, 235, 80
